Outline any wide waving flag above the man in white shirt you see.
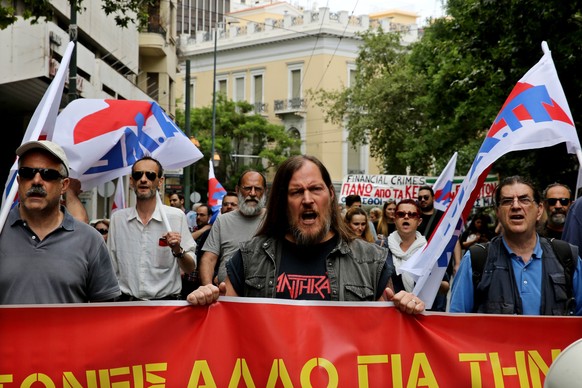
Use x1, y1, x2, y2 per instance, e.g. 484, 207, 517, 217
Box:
53, 99, 202, 190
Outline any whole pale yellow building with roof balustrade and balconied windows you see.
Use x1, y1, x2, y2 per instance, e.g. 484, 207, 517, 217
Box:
178, 2, 418, 182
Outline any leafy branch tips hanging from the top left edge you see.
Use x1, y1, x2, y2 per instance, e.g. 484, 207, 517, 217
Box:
0, 0, 153, 30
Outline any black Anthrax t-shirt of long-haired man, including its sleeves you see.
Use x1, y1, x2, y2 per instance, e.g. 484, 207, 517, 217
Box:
226, 236, 390, 300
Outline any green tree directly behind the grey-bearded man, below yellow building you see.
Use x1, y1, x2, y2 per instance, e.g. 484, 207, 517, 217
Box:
176, 94, 301, 192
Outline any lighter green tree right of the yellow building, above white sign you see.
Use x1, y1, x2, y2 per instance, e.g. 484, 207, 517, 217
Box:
310, 29, 423, 173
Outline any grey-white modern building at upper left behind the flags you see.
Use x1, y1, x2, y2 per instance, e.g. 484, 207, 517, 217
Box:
0, 0, 179, 218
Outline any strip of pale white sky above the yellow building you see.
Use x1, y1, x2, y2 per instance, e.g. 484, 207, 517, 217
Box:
287, 0, 443, 25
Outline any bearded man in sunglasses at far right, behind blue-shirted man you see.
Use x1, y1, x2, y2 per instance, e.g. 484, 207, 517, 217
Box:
538, 183, 572, 239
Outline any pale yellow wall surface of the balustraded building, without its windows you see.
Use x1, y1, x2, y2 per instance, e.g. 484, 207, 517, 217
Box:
177, 5, 416, 182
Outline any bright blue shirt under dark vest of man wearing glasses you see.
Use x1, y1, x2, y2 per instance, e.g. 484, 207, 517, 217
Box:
449, 236, 582, 315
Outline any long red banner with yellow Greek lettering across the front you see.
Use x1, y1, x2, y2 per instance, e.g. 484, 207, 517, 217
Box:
0, 298, 582, 388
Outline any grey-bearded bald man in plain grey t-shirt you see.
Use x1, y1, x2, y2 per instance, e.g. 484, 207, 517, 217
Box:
198, 170, 267, 285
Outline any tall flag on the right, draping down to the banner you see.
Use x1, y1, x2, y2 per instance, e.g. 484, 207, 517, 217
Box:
400, 42, 582, 308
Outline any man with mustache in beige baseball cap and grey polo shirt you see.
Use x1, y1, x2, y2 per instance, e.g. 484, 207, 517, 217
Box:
0, 141, 120, 304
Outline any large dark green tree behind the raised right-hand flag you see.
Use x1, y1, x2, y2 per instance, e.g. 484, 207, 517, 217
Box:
410, 0, 582, 188
